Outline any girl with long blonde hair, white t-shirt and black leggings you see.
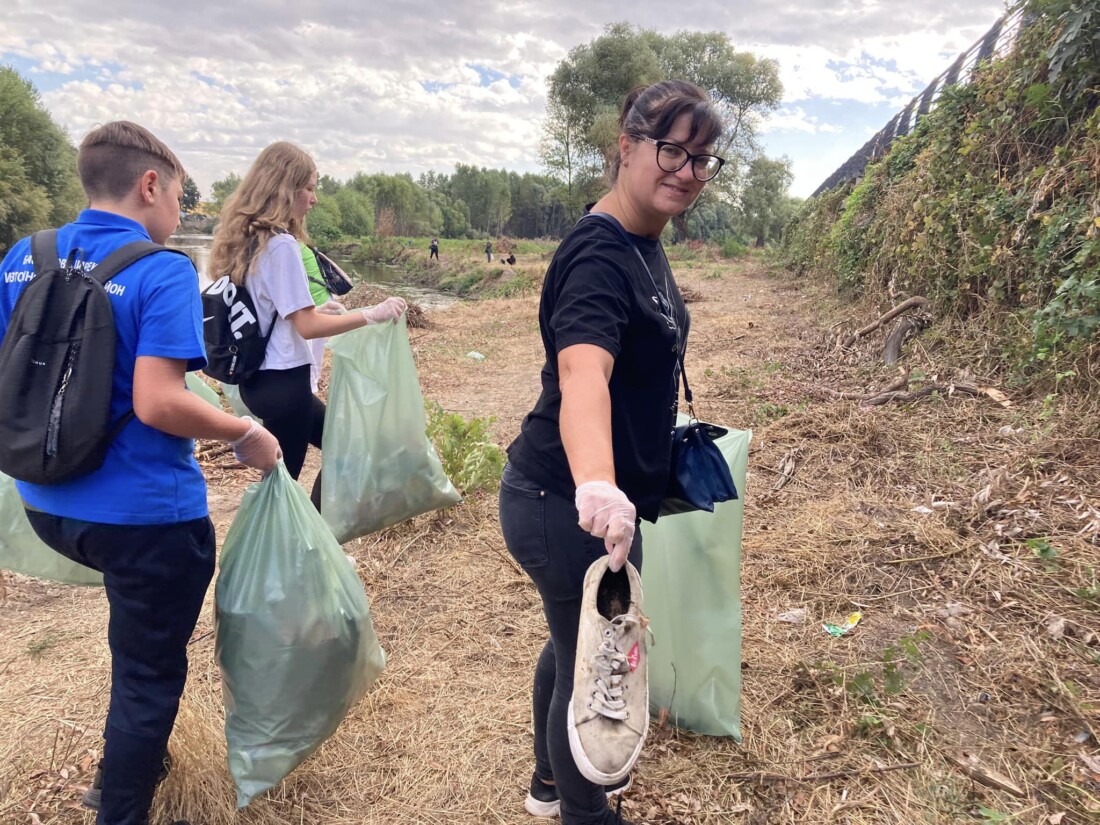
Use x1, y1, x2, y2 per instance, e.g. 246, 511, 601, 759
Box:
209, 141, 406, 508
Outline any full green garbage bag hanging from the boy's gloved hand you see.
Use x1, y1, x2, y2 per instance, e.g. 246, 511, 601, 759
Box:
215, 462, 386, 807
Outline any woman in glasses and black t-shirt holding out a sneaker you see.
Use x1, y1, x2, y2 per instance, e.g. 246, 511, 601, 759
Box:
501, 80, 724, 825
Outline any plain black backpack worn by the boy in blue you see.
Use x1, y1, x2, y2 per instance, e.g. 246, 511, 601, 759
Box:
0, 229, 189, 484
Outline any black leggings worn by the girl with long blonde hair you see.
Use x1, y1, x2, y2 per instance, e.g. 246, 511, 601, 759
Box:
241, 364, 325, 510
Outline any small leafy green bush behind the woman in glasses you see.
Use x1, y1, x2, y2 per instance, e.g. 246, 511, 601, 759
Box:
427, 402, 504, 495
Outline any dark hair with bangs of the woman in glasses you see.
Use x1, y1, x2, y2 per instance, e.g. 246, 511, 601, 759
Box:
609, 80, 722, 183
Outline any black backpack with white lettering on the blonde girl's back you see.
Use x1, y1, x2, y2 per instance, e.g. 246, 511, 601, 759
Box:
202, 275, 278, 384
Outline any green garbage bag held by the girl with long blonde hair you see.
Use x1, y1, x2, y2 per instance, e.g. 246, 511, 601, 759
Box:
321, 317, 462, 543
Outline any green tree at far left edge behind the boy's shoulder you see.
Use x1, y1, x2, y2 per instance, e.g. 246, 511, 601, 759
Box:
0, 66, 87, 252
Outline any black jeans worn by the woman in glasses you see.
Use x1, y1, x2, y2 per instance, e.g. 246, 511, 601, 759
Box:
499, 464, 641, 825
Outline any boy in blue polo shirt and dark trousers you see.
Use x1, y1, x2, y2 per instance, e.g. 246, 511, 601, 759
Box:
0, 121, 279, 825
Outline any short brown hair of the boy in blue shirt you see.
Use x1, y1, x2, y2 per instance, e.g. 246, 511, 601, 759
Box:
76, 120, 187, 200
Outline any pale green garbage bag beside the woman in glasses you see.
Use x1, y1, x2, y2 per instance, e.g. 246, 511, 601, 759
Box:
641, 416, 752, 741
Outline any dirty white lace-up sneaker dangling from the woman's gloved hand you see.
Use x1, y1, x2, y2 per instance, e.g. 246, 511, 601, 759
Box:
569, 556, 649, 785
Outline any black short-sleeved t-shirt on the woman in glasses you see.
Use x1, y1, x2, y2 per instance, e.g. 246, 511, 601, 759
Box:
508, 218, 691, 521
